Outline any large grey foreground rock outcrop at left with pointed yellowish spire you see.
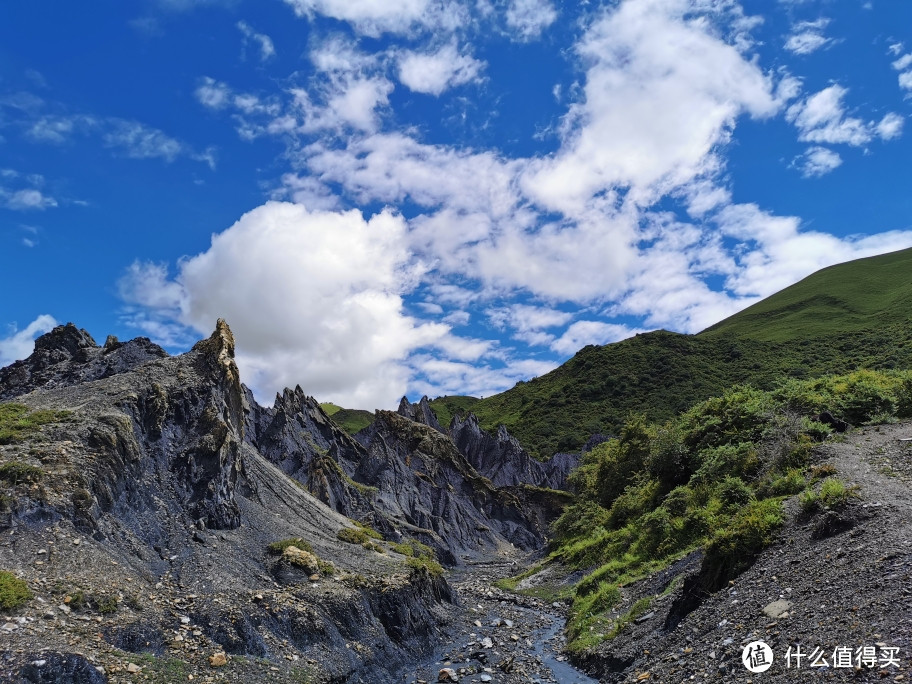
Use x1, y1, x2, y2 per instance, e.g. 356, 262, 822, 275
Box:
0, 321, 452, 682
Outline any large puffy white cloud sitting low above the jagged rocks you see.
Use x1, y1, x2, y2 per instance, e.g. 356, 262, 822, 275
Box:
121, 202, 449, 408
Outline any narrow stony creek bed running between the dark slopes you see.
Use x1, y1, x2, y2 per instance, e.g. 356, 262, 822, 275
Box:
400, 564, 598, 684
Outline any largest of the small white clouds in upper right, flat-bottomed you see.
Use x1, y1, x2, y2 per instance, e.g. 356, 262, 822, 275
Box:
786, 84, 902, 147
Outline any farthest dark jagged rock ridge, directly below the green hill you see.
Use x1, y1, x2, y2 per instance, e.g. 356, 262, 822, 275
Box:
449, 413, 579, 489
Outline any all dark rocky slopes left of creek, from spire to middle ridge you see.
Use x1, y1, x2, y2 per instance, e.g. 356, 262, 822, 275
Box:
0, 321, 584, 683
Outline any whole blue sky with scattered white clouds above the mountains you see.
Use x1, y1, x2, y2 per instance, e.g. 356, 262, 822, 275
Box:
0, 0, 912, 408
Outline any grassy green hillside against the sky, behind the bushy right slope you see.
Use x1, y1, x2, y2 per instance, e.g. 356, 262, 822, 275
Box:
431, 249, 912, 457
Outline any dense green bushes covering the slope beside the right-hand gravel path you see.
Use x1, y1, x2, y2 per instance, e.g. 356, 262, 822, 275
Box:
527, 371, 912, 651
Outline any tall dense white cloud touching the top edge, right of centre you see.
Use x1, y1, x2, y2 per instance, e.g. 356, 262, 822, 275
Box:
523, 0, 781, 214
